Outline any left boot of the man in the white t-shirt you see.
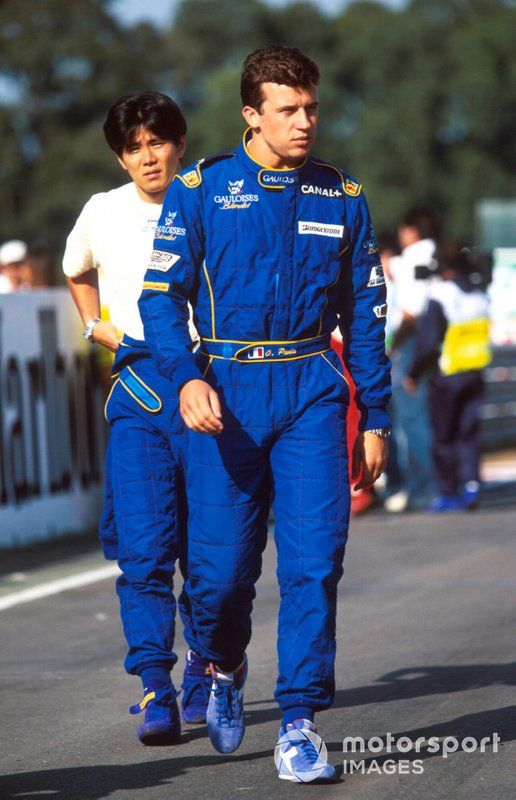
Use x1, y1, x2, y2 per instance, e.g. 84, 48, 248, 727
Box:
129, 686, 181, 746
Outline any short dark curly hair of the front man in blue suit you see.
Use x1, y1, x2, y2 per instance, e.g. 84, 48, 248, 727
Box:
240, 44, 320, 111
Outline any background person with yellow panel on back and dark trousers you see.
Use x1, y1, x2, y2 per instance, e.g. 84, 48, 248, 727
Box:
405, 245, 491, 512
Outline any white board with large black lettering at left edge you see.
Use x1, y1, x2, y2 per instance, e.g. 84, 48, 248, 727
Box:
0, 289, 106, 548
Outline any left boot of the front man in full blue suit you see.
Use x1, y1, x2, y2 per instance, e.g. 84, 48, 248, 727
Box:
206, 656, 247, 753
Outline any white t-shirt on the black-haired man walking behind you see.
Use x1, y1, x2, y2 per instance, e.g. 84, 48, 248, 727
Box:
63, 183, 197, 340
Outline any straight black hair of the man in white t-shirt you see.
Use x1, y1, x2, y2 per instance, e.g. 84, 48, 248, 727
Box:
103, 92, 186, 156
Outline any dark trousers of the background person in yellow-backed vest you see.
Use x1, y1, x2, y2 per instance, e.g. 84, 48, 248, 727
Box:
429, 370, 484, 494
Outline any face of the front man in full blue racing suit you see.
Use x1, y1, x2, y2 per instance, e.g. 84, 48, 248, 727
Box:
243, 83, 319, 167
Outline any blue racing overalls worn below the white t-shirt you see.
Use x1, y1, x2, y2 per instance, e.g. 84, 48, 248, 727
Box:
100, 334, 196, 675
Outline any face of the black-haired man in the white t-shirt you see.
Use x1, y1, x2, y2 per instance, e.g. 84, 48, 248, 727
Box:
117, 126, 185, 203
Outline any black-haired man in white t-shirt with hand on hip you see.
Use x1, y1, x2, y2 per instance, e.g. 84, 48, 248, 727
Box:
63, 92, 210, 744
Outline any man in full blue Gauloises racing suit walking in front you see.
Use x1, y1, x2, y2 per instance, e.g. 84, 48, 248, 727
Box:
139, 45, 390, 780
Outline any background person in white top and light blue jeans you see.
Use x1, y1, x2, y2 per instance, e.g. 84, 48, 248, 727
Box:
385, 207, 438, 512
